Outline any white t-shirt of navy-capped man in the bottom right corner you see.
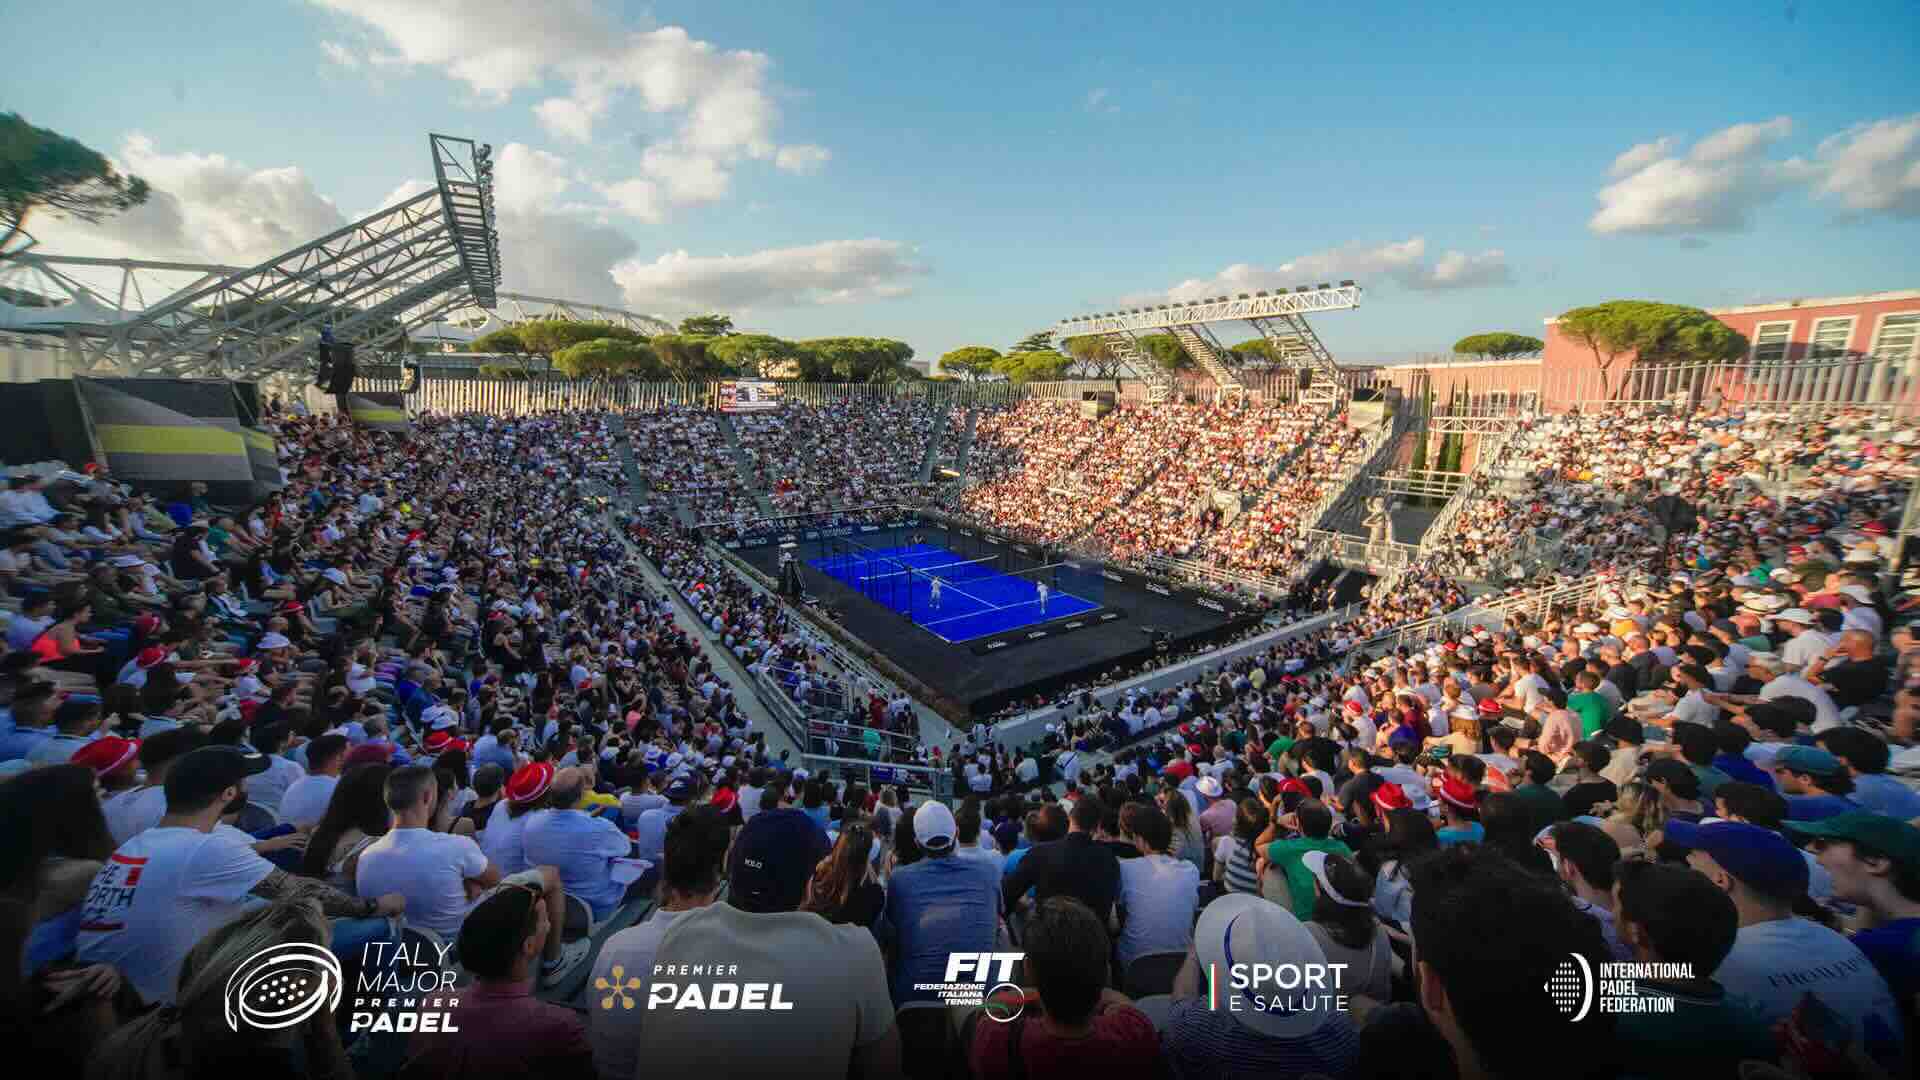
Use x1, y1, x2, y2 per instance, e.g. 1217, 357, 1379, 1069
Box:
1713, 917, 1901, 1040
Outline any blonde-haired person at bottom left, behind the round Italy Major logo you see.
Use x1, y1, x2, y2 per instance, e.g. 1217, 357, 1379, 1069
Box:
86, 899, 353, 1080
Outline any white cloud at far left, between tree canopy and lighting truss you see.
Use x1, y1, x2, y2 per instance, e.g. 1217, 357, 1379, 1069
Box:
29, 135, 346, 265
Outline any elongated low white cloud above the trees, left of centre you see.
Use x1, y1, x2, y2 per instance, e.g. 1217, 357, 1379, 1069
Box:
612, 240, 927, 311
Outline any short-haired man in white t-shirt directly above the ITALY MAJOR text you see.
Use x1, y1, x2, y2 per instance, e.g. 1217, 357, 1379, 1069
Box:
353, 765, 501, 938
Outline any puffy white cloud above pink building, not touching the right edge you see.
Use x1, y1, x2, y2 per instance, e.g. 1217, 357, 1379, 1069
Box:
1588, 117, 1805, 234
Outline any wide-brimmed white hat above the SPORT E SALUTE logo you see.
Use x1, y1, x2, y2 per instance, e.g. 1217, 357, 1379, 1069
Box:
1194, 894, 1350, 1038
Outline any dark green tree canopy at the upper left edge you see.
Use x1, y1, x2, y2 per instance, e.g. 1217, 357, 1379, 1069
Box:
0, 113, 152, 252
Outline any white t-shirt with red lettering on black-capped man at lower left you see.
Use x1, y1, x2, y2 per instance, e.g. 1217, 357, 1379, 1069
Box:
79, 826, 273, 1003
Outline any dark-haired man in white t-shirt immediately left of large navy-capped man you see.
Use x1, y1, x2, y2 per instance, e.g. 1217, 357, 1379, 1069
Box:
574, 807, 732, 1080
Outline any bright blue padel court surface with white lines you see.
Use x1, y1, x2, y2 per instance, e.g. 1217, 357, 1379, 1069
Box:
806, 544, 1100, 642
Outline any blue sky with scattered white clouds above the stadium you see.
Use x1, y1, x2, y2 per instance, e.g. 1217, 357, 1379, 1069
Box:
0, 0, 1920, 359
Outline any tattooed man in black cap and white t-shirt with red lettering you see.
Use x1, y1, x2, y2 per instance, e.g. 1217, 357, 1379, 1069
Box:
79, 746, 405, 1003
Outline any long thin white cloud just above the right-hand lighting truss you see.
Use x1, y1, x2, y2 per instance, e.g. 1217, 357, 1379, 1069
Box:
1121, 236, 1513, 304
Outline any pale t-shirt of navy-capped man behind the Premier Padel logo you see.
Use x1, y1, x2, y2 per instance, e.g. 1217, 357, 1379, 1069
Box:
639, 903, 893, 1076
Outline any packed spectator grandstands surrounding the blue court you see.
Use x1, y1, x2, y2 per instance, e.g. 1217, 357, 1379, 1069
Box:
0, 380, 1920, 1080
